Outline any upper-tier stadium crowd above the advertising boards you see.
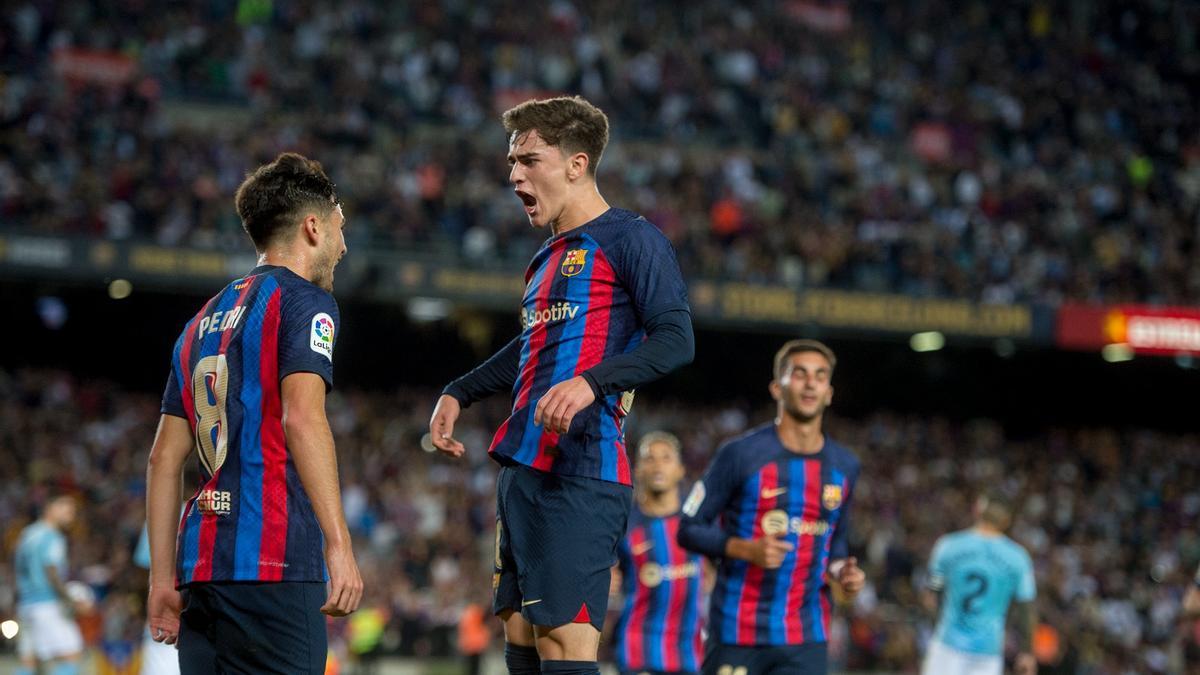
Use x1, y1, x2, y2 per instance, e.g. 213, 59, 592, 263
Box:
0, 0, 1200, 304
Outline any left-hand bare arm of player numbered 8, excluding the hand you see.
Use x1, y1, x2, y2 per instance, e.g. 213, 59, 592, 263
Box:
146, 414, 193, 581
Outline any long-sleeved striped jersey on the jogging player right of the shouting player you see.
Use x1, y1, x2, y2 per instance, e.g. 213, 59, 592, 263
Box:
680, 424, 859, 646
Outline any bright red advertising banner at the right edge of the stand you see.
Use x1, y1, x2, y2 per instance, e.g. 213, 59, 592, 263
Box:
1056, 303, 1200, 356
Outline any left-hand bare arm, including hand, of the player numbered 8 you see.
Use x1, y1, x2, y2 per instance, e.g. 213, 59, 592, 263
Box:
146, 410, 194, 644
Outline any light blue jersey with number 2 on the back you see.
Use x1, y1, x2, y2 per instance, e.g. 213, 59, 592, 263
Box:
929, 530, 1037, 656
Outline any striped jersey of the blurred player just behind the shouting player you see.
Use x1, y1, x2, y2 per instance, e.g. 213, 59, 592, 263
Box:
613, 508, 704, 673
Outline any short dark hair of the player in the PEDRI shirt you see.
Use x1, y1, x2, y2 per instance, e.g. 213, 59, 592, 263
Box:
234, 153, 337, 251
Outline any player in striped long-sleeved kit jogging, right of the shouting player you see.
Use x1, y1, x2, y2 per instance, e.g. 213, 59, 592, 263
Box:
679, 340, 866, 674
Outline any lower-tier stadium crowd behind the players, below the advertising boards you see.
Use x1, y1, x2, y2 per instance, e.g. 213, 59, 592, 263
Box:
0, 370, 1200, 675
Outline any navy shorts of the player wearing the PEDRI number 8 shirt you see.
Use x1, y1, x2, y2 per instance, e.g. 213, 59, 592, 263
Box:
179, 581, 329, 675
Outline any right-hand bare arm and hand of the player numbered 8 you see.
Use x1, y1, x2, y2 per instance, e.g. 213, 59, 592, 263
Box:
283, 372, 362, 616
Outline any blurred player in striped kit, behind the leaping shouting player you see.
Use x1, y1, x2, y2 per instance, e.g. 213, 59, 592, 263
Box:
613, 432, 703, 674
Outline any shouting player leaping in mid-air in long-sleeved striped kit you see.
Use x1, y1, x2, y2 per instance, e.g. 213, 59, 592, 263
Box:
430, 97, 694, 674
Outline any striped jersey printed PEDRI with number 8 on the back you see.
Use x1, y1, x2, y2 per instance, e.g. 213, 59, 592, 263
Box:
162, 265, 340, 586
